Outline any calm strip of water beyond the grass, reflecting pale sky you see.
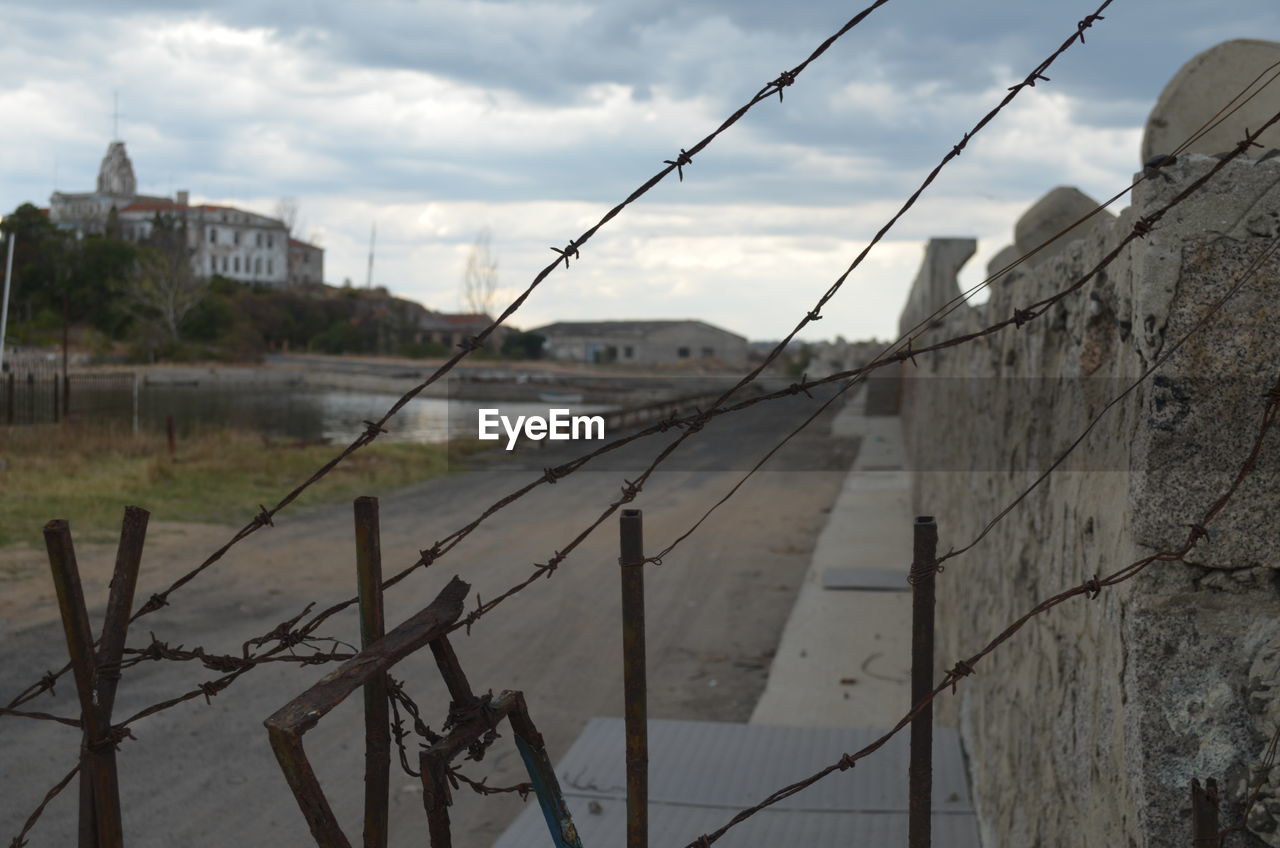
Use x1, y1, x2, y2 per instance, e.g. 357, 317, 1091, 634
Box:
132, 386, 611, 443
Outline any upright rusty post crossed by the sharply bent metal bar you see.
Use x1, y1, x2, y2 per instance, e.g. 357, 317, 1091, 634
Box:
353, 499, 392, 848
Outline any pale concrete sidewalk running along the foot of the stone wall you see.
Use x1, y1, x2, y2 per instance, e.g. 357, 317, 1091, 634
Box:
751, 389, 913, 728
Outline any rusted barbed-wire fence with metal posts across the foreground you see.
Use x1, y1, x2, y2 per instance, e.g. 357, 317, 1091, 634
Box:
3, 0, 1280, 848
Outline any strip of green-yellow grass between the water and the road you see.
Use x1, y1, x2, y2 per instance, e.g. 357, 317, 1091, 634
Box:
0, 421, 481, 547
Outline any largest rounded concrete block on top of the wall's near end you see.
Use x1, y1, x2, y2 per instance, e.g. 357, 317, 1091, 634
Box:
1139, 38, 1280, 163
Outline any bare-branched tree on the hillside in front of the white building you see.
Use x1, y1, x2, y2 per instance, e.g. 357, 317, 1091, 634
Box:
123, 215, 209, 342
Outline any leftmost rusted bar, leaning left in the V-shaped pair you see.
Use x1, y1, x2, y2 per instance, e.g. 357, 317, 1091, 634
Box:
45, 519, 124, 848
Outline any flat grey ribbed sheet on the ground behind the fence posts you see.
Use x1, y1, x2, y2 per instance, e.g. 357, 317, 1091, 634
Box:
494, 719, 979, 848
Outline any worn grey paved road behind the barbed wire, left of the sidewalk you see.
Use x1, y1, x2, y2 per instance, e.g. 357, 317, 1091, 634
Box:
0, 386, 855, 848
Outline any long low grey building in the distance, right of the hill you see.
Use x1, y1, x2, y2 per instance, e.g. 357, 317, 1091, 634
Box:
532, 320, 750, 366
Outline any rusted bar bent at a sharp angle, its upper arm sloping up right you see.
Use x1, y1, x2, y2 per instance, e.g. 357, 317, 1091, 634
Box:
264, 576, 471, 848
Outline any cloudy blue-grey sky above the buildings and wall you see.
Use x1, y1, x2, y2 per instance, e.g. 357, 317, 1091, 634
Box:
0, 0, 1280, 338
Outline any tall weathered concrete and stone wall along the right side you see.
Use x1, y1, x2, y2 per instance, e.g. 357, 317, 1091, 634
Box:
902, 151, 1280, 848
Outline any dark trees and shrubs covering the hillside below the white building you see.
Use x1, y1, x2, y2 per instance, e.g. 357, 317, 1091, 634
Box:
0, 204, 541, 361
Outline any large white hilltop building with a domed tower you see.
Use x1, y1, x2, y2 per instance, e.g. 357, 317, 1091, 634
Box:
49, 141, 324, 287
